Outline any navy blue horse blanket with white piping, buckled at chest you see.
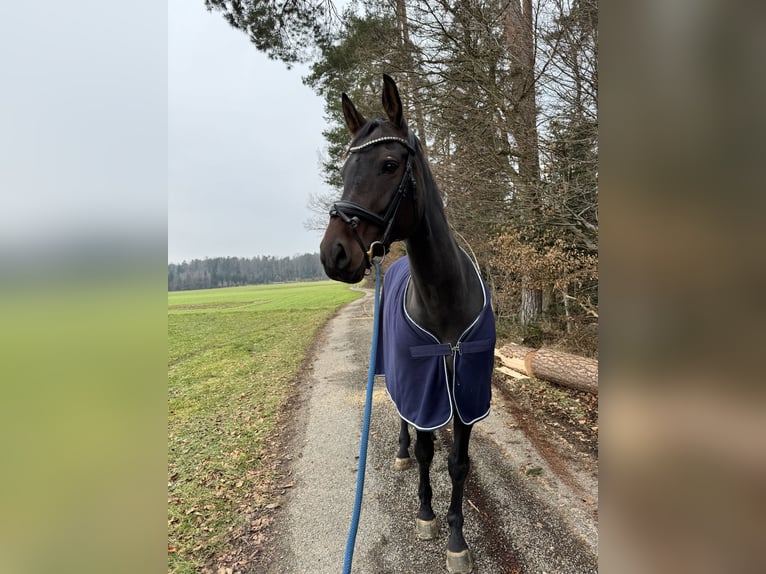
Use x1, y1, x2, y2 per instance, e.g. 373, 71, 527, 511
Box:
375, 257, 495, 431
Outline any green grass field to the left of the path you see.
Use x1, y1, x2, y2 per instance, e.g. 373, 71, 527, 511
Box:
168, 281, 361, 574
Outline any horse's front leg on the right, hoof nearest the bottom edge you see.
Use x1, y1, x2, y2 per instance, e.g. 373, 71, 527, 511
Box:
447, 416, 473, 574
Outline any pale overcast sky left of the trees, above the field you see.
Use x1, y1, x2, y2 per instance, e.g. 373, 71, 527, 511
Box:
168, 0, 334, 263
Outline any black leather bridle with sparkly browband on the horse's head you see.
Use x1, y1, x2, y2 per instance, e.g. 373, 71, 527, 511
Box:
330, 133, 415, 269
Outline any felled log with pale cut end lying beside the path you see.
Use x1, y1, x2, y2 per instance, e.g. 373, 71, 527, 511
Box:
495, 343, 598, 395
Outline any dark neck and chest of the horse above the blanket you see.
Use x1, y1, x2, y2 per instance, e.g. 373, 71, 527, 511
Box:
407, 189, 484, 343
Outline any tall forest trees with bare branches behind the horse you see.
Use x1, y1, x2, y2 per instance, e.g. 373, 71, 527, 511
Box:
206, 0, 599, 355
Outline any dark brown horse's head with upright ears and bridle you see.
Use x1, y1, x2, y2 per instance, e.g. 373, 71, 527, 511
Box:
319, 74, 423, 283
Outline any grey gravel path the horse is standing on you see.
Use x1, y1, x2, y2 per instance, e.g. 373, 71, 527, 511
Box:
265, 294, 598, 574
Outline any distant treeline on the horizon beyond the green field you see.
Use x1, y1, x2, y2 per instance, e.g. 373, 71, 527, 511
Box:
168, 253, 327, 291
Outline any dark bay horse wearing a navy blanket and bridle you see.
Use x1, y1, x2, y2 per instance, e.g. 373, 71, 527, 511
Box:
320, 74, 496, 573
